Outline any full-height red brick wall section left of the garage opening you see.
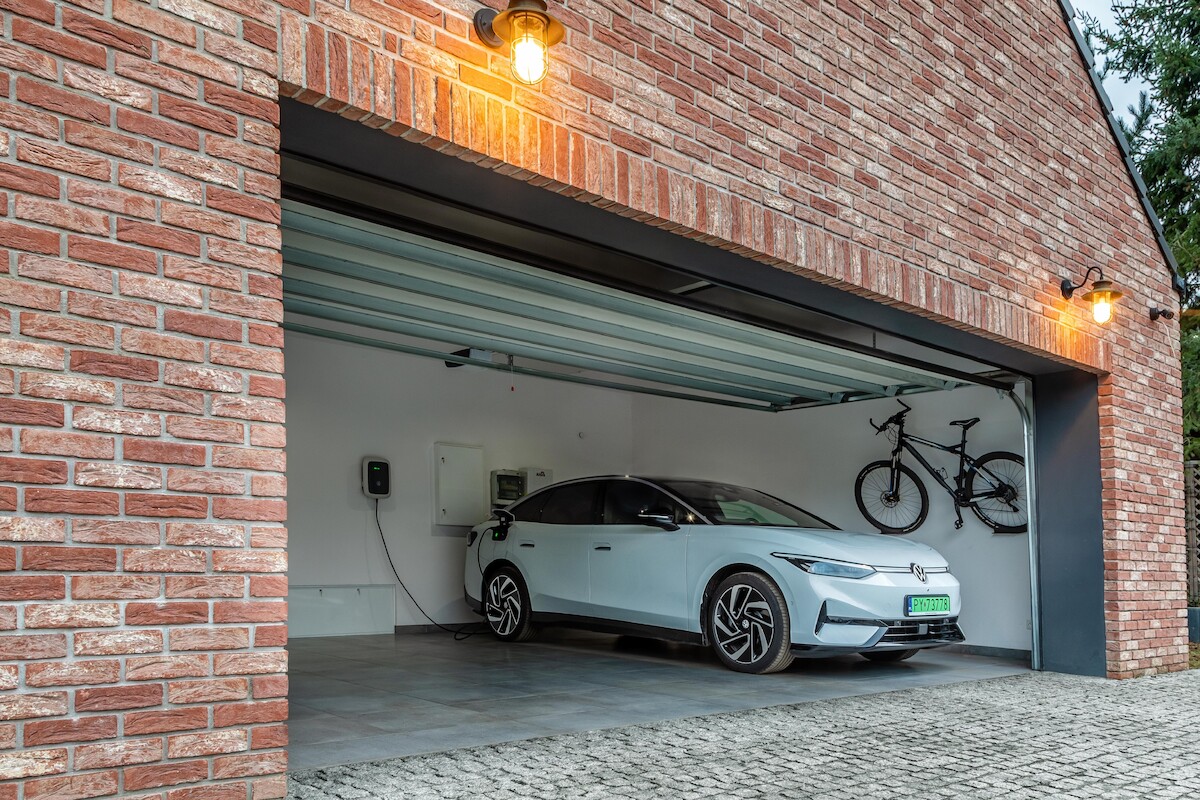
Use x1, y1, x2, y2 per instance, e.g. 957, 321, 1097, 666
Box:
0, 0, 287, 800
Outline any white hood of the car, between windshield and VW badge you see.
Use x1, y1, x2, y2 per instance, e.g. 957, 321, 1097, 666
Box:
697, 525, 948, 567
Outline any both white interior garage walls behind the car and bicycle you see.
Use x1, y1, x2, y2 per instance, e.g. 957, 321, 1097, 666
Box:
287, 332, 1030, 650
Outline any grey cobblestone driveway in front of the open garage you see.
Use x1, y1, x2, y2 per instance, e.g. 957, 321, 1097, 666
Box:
290, 670, 1200, 800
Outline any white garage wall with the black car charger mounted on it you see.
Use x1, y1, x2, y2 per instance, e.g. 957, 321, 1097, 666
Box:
286, 332, 632, 633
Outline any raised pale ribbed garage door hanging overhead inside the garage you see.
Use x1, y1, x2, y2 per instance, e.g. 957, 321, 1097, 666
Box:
283, 200, 993, 411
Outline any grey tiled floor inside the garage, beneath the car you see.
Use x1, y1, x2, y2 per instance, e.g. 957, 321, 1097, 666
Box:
288, 631, 1027, 771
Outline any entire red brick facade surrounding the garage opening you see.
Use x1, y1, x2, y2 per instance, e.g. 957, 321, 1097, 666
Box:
0, 0, 1186, 800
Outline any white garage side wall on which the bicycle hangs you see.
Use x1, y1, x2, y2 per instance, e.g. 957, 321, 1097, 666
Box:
634, 387, 1031, 650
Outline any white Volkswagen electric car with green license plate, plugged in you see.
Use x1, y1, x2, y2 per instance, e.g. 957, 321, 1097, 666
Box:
464, 476, 964, 673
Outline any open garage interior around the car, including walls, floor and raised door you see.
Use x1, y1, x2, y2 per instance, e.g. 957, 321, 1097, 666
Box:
276, 164, 1036, 769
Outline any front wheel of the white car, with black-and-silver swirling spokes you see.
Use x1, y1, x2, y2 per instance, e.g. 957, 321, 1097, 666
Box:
706, 572, 792, 675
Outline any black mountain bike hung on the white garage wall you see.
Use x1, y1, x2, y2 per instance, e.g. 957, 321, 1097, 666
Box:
854, 402, 1030, 534
